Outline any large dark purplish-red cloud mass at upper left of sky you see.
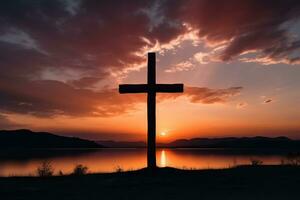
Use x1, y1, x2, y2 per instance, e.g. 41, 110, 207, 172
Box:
0, 0, 183, 79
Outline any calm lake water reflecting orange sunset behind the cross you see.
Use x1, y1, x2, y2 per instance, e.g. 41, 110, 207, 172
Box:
0, 149, 284, 176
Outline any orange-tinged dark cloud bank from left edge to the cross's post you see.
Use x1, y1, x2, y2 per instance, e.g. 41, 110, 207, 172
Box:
0, 78, 143, 117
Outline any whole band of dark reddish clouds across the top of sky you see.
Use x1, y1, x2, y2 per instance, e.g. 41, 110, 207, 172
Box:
0, 0, 300, 78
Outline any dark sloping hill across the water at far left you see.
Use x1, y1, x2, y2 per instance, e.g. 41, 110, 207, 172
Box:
0, 129, 103, 149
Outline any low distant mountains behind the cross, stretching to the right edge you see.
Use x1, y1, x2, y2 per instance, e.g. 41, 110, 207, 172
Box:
97, 136, 300, 149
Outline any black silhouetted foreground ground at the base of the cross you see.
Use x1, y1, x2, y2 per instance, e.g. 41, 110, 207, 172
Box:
0, 166, 300, 200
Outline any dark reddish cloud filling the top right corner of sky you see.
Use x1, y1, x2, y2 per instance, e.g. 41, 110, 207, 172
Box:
173, 0, 300, 64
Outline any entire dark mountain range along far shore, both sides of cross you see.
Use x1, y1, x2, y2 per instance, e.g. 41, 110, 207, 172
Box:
0, 129, 300, 150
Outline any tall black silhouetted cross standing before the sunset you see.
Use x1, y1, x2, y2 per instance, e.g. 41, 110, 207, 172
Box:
119, 52, 183, 169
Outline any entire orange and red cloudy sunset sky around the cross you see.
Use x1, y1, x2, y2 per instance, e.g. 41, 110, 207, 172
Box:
0, 0, 300, 141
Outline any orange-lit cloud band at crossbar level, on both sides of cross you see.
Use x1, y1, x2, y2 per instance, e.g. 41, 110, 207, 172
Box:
0, 78, 242, 117
